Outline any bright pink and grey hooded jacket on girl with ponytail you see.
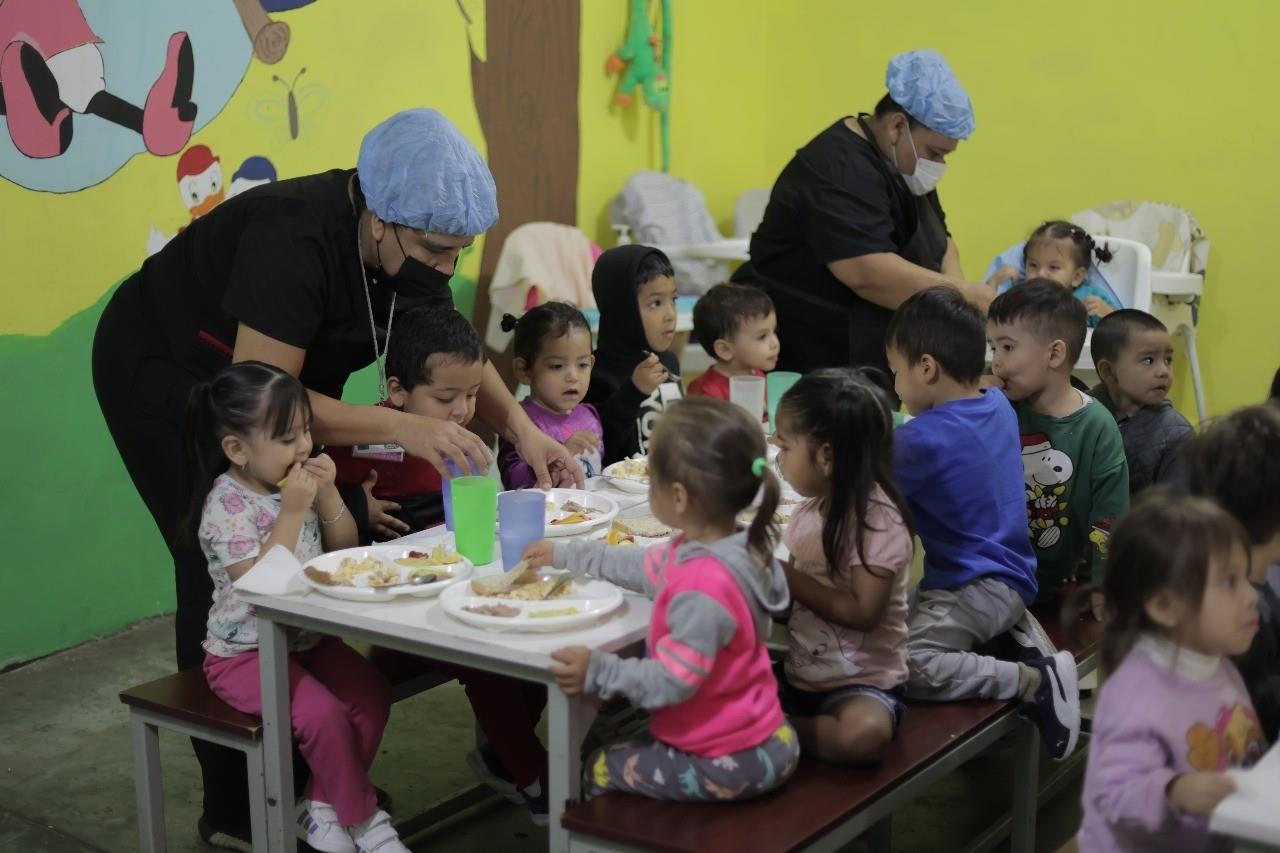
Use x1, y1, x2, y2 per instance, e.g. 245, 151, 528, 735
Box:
556, 532, 790, 758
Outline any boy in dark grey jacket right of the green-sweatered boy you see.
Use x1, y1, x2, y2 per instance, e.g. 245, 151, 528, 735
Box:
1089, 309, 1193, 497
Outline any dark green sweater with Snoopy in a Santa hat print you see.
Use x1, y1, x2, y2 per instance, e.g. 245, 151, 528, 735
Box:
1014, 394, 1129, 599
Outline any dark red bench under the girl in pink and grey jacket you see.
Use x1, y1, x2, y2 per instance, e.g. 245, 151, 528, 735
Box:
562, 596, 1101, 853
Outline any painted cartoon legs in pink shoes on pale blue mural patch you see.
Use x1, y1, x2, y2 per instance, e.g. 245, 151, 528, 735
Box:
0, 0, 310, 192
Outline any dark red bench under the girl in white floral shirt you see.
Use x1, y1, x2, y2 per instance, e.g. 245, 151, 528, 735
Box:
120, 656, 490, 853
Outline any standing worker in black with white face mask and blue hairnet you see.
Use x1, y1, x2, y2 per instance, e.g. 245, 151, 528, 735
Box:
736, 50, 993, 373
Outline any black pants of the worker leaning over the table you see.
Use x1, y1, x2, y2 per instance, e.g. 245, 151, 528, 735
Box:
93, 278, 306, 834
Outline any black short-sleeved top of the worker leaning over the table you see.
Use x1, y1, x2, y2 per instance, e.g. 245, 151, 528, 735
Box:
131, 169, 389, 397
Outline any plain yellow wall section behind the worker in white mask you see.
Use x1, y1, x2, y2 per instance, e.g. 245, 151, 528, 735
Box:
764, 0, 1280, 415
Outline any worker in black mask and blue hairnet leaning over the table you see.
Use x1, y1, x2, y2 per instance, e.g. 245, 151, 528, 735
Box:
93, 104, 582, 840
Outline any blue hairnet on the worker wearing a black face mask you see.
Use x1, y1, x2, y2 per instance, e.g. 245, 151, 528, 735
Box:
356, 109, 498, 237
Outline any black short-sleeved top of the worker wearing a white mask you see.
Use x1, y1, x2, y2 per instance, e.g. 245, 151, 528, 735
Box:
735, 115, 947, 373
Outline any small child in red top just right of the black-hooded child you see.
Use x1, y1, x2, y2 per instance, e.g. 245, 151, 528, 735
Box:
689, 284, 778, 409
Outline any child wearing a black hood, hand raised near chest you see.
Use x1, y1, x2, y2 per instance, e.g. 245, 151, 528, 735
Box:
586, 245, 681, 465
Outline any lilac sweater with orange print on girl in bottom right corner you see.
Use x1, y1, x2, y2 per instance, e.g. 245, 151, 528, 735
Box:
1079, 635, 1266, 853
